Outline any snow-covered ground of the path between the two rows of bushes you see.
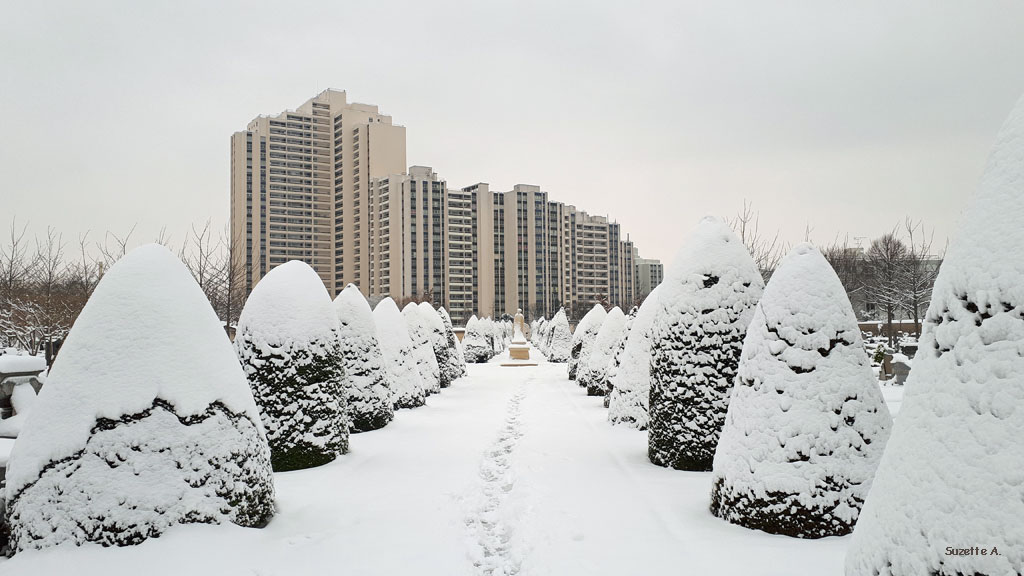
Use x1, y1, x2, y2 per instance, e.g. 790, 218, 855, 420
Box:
0, 351, 902, 576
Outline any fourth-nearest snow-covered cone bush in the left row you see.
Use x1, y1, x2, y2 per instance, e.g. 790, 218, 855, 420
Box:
374, 298, 427, 408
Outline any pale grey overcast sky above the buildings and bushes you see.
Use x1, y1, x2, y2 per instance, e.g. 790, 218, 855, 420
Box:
0, 0, 1024, 260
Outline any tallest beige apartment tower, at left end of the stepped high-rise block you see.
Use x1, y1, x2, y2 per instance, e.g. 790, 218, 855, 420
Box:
231, 90, 406, 295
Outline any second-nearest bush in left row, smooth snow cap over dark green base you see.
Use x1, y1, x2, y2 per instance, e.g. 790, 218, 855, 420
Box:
234, 260, 348, 471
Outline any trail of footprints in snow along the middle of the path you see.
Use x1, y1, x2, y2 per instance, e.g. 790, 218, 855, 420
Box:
466, 382, 526, 576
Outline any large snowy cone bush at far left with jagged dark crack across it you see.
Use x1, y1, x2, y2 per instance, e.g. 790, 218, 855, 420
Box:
5, 245, 273, 552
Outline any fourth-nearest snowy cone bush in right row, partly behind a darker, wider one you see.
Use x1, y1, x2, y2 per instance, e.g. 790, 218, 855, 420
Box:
608, 285, 662, 430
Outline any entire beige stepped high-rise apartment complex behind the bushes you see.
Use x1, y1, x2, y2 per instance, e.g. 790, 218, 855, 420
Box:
231, 90, 638, 324
